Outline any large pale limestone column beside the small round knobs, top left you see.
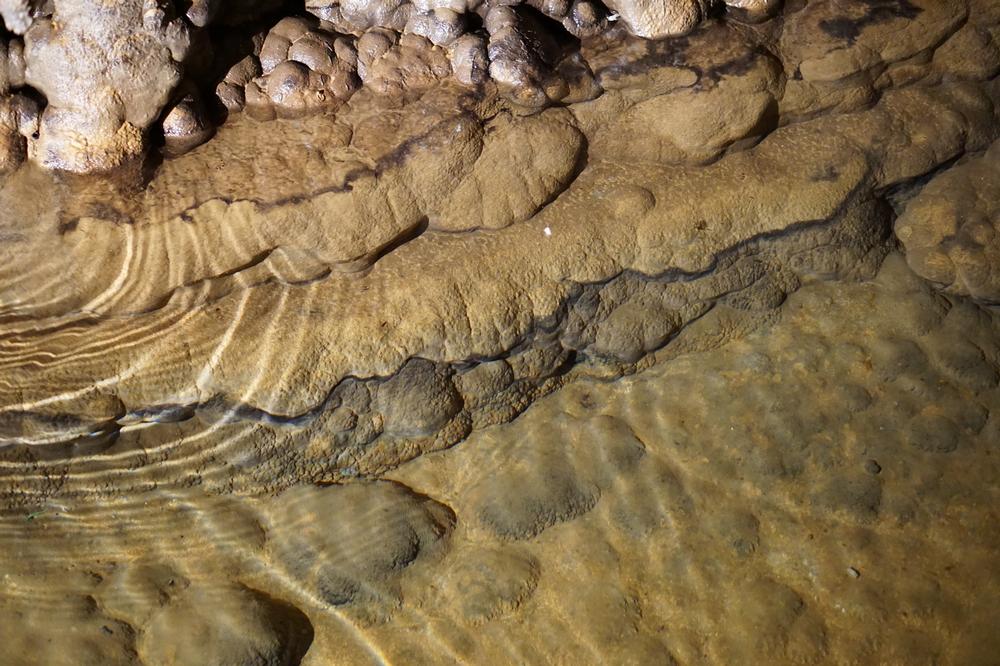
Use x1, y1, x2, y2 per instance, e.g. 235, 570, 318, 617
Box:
24, 0, 190, 172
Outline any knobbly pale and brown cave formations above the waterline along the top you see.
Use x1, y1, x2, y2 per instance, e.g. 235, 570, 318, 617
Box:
0, 0, 777, 173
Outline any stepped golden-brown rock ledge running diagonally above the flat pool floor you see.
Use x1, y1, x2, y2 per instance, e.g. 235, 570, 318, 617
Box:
0, 0, 998, 493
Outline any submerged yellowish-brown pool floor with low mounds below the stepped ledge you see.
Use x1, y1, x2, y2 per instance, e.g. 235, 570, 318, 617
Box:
0, 227, 1000, 664
